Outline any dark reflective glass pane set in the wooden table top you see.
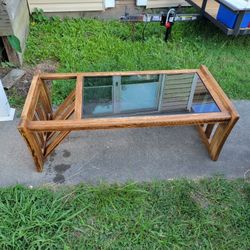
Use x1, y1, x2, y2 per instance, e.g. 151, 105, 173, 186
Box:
82, 73, 220, 118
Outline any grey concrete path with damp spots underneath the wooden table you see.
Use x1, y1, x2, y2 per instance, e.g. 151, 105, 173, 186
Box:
0, 101, 250, 186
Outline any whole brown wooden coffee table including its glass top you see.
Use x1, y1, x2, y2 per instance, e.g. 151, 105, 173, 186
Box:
18, 66, 239, 172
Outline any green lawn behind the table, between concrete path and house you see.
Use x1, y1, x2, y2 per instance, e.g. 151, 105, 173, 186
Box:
25, 19, 250, 103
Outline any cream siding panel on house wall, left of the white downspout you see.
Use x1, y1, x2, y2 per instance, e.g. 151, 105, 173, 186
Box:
28, 0, 104, 12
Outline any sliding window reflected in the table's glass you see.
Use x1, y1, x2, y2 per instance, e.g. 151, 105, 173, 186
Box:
83, 75, 161, 116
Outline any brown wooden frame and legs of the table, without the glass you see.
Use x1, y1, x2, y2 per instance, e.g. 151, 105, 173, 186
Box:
18, 66, 239, 172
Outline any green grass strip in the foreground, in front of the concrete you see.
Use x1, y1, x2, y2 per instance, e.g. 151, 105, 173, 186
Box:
0, 178, 250, 249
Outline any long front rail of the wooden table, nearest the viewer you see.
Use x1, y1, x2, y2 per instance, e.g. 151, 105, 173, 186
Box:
27, 112, 231, 131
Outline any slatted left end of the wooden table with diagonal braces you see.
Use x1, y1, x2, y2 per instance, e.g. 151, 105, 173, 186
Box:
18, 75, 75, 172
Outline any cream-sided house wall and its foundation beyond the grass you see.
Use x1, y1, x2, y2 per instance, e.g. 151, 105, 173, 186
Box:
28, 0, 188, 19
